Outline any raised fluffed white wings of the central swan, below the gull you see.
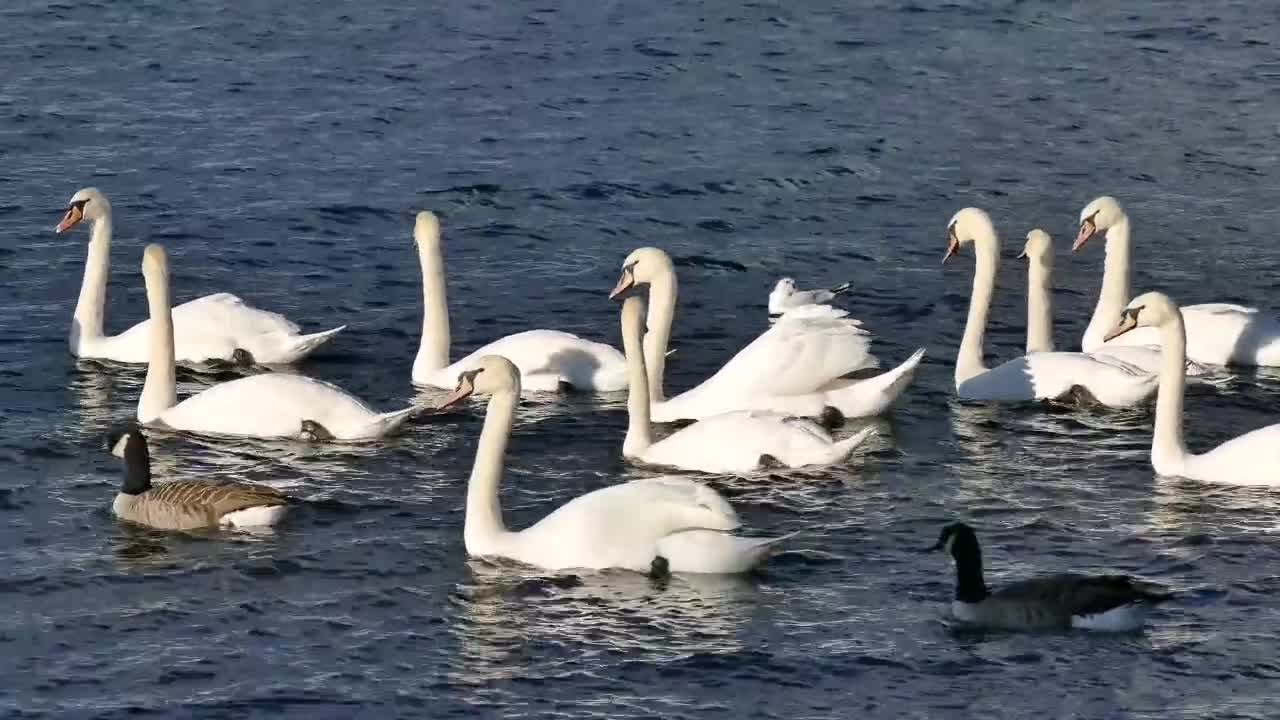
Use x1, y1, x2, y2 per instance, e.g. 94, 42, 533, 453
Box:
672, 305, 877, 406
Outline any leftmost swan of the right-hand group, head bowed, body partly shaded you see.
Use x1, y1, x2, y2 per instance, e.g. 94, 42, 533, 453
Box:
942, 208, 1156, 407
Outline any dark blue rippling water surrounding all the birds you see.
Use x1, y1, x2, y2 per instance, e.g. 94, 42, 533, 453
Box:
0, 0, 1280, 719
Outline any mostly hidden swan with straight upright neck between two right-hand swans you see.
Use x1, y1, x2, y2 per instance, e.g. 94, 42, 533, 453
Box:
1019, 228, 1211, 378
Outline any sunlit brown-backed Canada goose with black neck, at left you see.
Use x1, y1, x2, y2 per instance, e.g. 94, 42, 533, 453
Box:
108, 428, 291, 530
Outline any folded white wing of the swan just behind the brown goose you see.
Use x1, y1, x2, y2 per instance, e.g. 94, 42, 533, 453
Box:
159, 373, 404, 439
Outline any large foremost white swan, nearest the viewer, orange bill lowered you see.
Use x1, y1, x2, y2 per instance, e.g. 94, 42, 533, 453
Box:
442, 355, 785, 573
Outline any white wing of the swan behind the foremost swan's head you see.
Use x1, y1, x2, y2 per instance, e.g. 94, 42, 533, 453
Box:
430, 329, 627, 392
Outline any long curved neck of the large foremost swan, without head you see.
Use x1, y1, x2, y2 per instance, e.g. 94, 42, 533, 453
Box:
462, 382, 520, 555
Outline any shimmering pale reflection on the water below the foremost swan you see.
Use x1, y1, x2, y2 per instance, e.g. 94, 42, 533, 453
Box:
451, 560, 758, 685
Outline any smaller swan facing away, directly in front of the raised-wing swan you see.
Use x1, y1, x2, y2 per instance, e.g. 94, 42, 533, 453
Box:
622, 293, 874, 473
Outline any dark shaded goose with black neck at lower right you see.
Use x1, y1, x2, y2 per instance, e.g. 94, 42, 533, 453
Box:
931, 523, 1171, 632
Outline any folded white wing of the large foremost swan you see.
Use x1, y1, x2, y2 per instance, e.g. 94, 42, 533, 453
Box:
512, 475, 741, 571
